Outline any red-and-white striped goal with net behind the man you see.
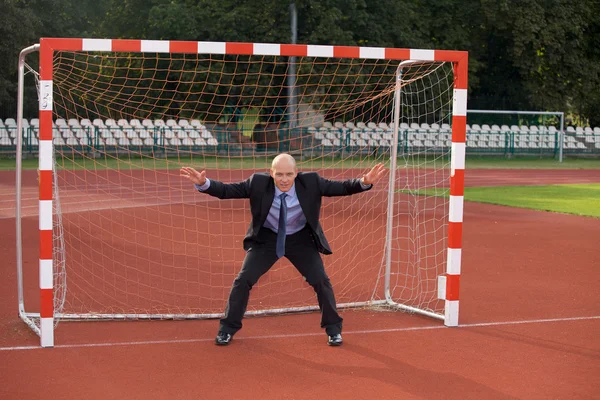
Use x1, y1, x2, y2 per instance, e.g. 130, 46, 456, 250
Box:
17, 38, 467, 347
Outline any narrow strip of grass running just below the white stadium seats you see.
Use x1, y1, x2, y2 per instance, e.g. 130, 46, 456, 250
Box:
0, 155, 600, 171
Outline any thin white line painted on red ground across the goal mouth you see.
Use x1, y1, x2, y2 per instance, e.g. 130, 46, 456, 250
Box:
0, 315, 600, 351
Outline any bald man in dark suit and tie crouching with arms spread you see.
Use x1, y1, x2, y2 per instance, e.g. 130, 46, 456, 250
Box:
180, 154, 385, 346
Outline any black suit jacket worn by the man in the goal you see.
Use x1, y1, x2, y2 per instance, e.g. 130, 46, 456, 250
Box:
205, 172, 372, 254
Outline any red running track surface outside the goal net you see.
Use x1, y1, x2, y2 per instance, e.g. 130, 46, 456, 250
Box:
0, 170, 600, 400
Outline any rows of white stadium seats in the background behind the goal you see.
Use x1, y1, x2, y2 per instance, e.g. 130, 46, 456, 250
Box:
0, 118, 600, 153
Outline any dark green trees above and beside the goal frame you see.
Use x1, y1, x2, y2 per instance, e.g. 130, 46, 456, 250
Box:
0, 0, 600, 126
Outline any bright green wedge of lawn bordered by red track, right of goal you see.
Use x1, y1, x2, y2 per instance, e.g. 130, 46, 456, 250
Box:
417, 183, 600, 218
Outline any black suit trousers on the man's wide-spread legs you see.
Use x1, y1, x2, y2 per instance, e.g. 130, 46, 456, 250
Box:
219, 227, 342, 335
